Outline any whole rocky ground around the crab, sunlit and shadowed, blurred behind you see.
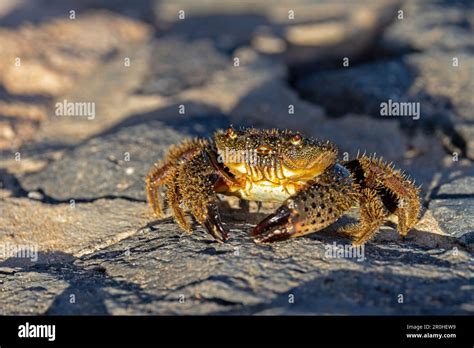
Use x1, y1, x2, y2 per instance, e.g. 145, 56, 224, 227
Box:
0, 0, 474, 314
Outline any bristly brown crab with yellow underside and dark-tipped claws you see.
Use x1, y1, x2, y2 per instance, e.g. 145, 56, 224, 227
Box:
146, 127, 421, 245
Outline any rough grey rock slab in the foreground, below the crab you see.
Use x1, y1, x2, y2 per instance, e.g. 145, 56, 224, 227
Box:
0, 222, 472, 314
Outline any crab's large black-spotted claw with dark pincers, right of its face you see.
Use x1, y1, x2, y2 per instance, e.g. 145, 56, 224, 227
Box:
252, 164, 359, 243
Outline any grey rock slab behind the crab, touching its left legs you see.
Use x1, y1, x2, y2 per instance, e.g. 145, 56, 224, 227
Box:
20, 110, 229, 201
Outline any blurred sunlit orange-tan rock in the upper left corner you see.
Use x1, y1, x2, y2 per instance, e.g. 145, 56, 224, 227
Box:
0, 12, 151, 150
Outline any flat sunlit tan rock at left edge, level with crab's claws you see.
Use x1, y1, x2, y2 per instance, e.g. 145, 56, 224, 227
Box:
0, 198, 147, 262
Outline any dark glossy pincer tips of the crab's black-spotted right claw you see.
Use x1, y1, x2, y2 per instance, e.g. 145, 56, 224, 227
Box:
252, 205, 295, 243
